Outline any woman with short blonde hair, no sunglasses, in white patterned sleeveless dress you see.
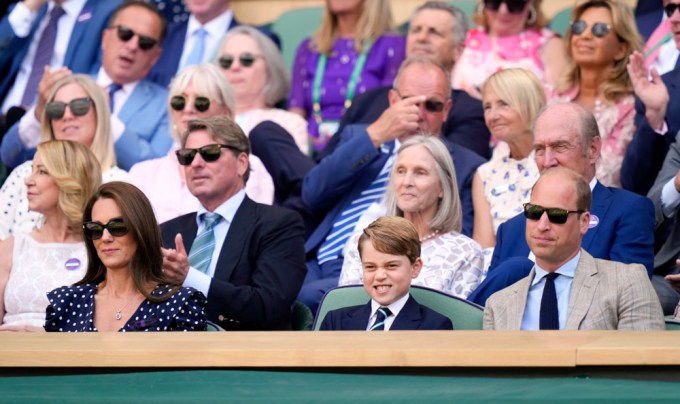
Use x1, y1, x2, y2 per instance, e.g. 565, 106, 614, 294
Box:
472, 69, 546, 248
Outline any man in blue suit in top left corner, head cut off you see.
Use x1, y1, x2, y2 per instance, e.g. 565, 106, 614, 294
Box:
0, 0, 122, 133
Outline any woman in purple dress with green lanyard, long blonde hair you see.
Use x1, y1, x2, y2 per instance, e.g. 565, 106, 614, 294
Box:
288, 0, 406, 151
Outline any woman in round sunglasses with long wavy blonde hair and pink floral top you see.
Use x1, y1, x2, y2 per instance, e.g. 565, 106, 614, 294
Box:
548, 0, 643, 187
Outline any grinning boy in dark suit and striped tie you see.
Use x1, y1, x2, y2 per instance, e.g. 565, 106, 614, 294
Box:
320, 216, 453, 331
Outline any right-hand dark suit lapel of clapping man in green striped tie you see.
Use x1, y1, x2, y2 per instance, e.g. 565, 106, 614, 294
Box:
214, 196, 258, 281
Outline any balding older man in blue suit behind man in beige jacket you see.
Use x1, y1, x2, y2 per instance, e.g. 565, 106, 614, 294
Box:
468, 104, 654, 305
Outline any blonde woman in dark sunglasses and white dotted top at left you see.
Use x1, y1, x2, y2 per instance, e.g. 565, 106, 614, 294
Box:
0, 74, 127, 239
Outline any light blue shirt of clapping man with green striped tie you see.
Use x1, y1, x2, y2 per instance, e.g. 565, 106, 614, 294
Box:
182, 189, 246, 296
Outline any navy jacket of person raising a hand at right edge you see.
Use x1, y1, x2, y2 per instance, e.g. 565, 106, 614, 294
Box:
621, 68, 680, 195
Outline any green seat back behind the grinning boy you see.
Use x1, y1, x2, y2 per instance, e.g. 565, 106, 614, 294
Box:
314, 285, 484, 330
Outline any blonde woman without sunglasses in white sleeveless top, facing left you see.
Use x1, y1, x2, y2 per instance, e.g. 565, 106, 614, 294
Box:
0, 140, 101, 331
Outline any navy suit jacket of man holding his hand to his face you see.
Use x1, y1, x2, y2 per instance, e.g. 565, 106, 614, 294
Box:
302, 125, 484, 253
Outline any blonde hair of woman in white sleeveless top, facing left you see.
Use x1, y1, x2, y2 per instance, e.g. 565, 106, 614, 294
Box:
36, 140, 102, 232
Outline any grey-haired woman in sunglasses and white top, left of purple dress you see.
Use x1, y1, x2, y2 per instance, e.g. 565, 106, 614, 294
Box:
216, 25, 309, 154
